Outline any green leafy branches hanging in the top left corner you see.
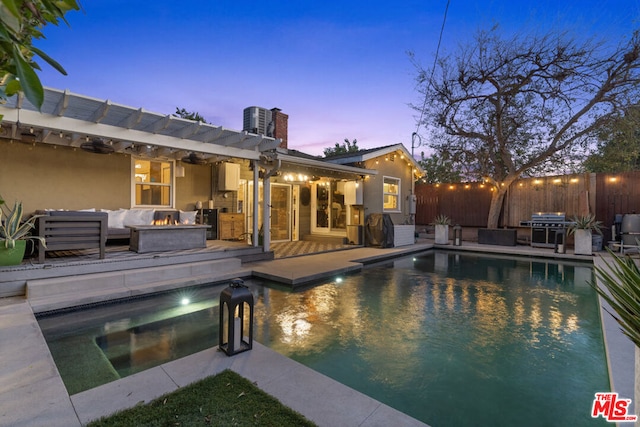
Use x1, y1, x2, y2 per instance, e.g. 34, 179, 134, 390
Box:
0, 0, 80, 108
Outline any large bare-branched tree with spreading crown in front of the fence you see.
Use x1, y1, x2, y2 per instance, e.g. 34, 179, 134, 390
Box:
412, 27, 640, 228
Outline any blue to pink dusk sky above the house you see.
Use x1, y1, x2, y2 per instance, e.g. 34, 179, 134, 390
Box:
36, 0, 640, 155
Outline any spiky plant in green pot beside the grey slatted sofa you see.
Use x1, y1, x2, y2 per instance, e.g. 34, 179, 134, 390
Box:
0, 198, 45, 265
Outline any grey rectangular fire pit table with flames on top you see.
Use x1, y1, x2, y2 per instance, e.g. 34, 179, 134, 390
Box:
127, 224, 209, 253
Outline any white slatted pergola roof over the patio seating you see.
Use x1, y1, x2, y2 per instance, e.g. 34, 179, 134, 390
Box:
0, 88, 281, 160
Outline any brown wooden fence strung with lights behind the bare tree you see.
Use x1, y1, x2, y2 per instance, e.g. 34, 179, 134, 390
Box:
416, 171, 640, 244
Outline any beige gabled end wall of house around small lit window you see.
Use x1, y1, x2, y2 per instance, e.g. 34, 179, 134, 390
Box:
363, 154, 413, 225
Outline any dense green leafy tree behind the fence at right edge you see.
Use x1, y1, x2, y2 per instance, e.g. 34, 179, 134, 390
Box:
584, 105, 640, 173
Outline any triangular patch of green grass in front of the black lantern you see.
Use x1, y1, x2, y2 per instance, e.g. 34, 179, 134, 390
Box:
88, 370, 315, 427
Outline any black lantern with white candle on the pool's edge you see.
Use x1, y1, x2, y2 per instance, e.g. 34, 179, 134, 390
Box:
218, 279, 253, 356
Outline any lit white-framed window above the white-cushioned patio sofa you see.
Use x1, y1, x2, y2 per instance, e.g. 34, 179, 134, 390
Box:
133, 159, 173, 207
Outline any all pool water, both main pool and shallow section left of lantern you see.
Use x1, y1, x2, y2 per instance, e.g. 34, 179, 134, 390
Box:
40, 252, 609, 426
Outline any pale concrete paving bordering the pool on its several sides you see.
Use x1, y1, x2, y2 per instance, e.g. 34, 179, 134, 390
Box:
0, 242, 634, 427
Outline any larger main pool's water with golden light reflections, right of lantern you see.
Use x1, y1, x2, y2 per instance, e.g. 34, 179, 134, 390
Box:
256, 252, 609, 426
